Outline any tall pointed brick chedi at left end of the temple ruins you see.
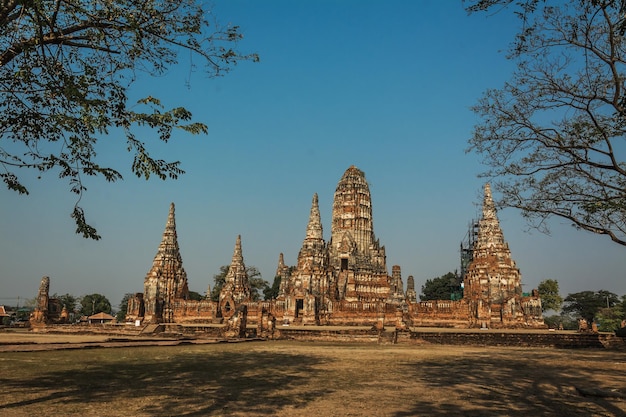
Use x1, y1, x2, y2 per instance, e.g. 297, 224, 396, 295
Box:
144, 203, 189, 322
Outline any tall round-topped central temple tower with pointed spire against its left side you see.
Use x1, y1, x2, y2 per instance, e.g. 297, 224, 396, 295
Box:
277, 166, 405, 325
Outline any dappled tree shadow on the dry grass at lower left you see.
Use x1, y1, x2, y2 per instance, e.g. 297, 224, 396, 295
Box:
0, 348, 327, 416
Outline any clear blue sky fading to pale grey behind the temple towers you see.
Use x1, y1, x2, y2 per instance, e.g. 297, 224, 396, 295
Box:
0, 0, 626, 307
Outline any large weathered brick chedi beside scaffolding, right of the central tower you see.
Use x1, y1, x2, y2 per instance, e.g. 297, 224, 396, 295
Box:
464, 184, 523, 327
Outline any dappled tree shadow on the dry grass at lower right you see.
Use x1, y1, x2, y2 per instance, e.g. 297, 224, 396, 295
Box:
394, 350, 626, 417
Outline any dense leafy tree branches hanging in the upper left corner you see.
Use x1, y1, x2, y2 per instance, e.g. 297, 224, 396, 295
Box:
0, 0, 258, 239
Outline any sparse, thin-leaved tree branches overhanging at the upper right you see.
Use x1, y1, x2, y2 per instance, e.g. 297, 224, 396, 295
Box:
467, 0, 626, 245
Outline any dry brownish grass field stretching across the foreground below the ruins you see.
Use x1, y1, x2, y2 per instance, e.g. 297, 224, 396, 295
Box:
0, 341, 626, 417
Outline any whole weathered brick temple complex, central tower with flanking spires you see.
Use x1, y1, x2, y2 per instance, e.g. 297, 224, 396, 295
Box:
127, 166, 543, 328
